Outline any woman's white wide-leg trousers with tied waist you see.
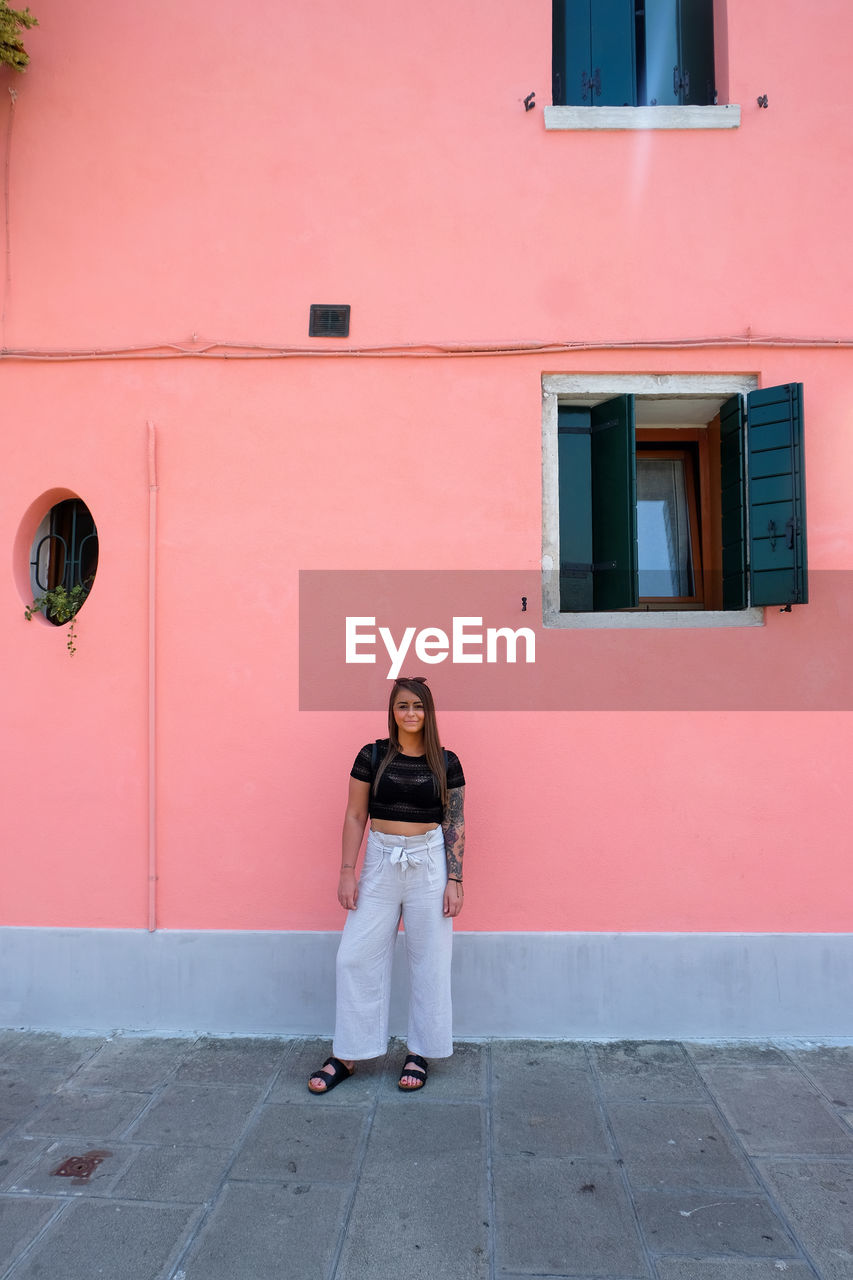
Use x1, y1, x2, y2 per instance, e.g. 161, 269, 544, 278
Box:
332, 827, 453, 1061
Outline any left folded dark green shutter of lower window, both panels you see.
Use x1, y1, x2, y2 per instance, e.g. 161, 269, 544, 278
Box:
557, 396, 639, 613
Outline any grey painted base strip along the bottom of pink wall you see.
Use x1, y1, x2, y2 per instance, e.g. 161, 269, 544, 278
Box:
0, 928, 853, 1039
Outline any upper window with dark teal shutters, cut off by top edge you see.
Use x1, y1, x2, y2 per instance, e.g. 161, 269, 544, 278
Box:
553, 0, 716, 106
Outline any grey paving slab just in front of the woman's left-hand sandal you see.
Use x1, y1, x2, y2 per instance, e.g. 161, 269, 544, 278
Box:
229, 1101, 368, 1183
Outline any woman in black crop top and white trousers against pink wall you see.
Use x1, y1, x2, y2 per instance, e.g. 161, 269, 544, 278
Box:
309, 676, 465, 1093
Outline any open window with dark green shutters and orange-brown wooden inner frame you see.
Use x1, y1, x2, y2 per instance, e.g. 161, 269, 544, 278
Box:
557, 383, 808, 613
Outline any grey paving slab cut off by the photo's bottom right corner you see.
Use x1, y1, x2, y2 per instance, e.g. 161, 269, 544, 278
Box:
761, 1160, 853, 1280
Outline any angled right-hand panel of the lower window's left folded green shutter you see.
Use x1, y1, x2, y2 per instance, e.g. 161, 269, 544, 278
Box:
589, 396, 639, 611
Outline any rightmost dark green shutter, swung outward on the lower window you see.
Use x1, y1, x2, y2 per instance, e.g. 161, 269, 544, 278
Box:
747, 383, 808, 604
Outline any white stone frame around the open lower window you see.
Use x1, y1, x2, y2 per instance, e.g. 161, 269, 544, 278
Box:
542, 371, 765, 631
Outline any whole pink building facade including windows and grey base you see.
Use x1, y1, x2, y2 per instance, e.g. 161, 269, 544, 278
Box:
0, 0, 853, 1038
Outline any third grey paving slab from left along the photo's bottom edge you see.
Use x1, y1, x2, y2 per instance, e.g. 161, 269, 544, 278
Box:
175, 1183, 348, 1280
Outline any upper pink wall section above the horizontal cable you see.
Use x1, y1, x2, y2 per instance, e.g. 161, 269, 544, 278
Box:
4, 0, 853, 346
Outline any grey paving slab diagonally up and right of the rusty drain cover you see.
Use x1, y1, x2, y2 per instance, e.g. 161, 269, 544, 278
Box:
128, 1084, 263, 1147
